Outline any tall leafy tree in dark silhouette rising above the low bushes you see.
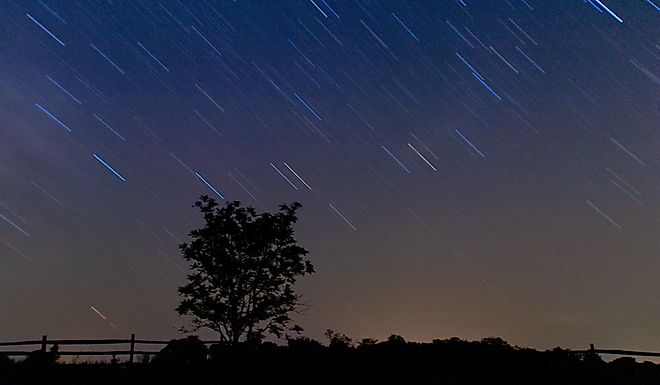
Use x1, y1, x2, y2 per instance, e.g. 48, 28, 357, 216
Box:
176, 195, 314, 345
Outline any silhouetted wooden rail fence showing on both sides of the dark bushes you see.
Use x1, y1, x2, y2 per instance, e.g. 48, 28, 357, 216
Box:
0, 334, 660, 363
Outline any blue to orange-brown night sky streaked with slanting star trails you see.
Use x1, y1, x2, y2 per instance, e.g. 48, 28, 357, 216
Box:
0, 0, 660, 351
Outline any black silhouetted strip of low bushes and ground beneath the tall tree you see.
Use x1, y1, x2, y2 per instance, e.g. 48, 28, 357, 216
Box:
0, 330, 660, 385
